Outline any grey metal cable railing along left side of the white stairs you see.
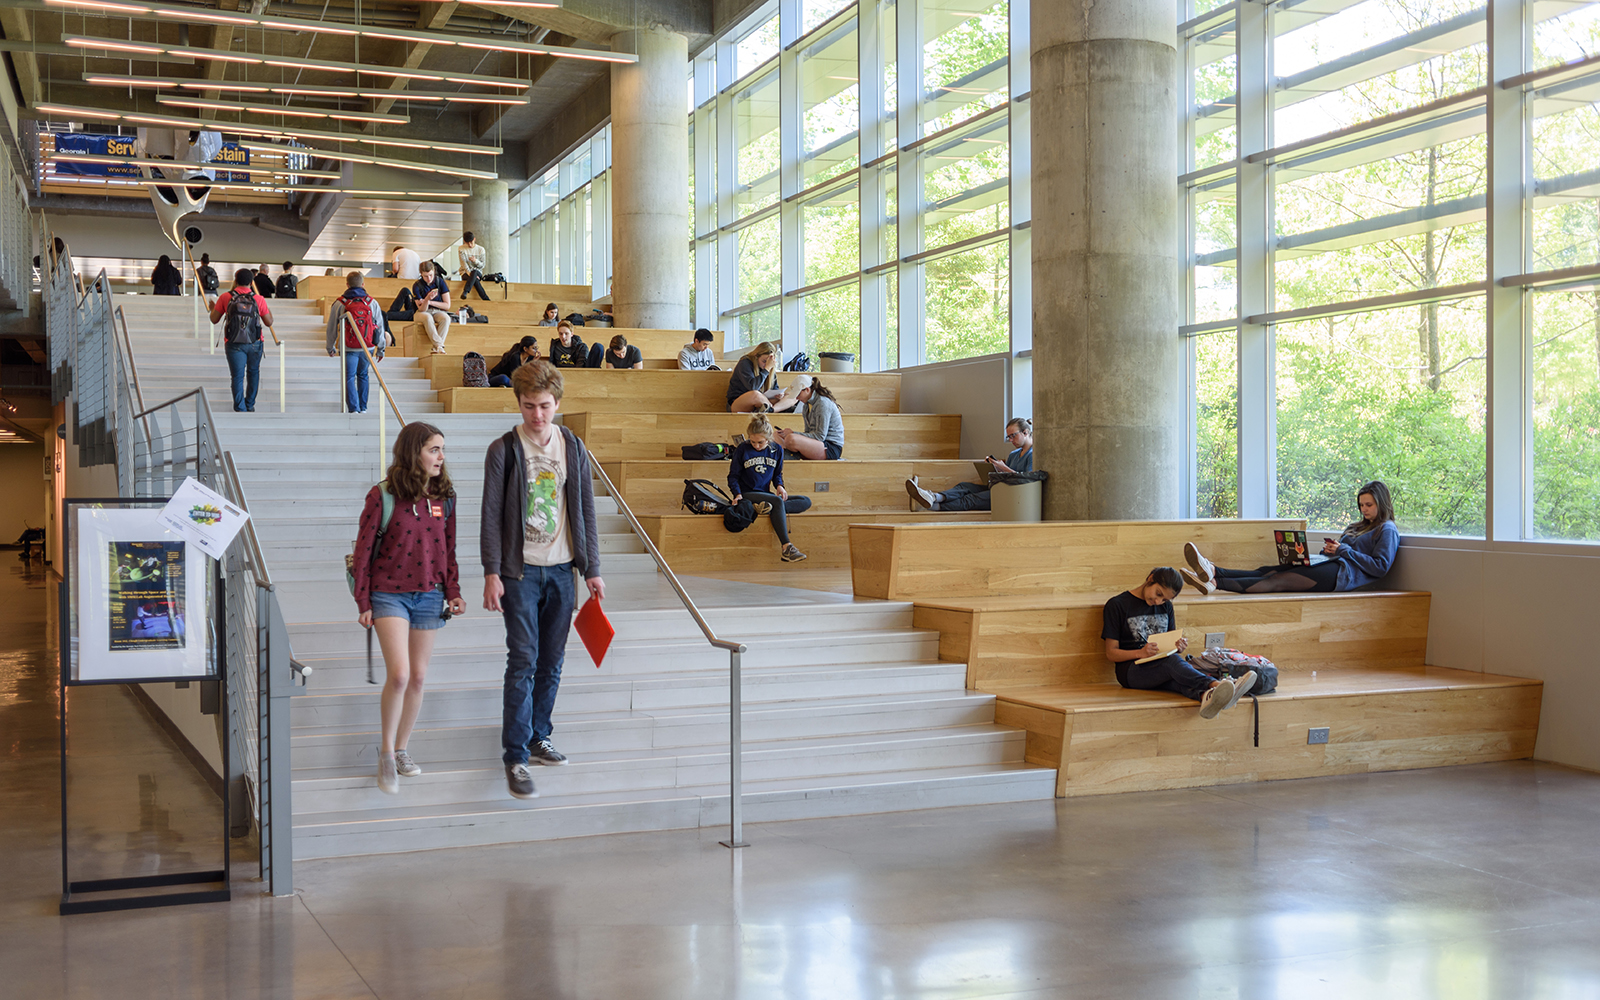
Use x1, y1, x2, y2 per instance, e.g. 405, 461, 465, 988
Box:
42, 233, 310, 896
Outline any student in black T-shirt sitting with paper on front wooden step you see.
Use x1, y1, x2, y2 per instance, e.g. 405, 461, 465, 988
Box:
1101, 566, 1256, 718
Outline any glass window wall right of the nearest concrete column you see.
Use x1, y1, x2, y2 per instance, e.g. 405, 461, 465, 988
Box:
1178, 0, 1600, 541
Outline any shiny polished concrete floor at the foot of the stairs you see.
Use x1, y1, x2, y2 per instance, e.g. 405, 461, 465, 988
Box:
0, 552, 1600, 1000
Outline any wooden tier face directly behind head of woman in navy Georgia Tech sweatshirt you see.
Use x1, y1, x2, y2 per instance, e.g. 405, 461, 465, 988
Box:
563, 409, 962, 460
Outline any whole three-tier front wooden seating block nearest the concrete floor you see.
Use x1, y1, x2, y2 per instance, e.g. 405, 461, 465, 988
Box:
850, 522, 1542, 795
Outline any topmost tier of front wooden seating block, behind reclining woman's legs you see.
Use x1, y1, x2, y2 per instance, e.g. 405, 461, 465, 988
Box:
846, 518, 1306, 600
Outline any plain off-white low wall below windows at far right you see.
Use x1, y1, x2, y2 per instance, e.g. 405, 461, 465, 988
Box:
1387, 536, 1600, 771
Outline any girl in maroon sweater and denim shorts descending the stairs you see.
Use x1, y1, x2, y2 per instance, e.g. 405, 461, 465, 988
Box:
355, 422, 467, 795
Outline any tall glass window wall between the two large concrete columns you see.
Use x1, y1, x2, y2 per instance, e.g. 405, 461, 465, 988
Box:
690, 0, 1027, 371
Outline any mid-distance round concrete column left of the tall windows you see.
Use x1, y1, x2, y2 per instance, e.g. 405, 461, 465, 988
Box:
611, 27, 690, 330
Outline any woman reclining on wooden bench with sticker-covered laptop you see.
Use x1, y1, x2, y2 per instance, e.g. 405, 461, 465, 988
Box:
1181, 480, 1400, 594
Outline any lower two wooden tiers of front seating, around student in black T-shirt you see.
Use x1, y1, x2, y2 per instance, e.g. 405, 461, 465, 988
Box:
914, 592, 1542, 795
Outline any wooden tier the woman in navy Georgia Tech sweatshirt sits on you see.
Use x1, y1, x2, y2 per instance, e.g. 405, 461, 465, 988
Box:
638, 512, 989, 573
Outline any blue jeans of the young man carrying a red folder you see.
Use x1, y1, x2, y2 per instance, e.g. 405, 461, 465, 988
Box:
501, 563, 578, 763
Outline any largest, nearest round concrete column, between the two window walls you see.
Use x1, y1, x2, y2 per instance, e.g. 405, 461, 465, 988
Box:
1030, 0, 1184, 520
